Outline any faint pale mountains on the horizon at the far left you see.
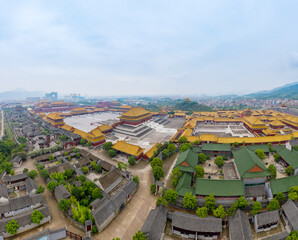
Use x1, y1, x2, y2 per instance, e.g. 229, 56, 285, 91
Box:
0, 88, 44, 100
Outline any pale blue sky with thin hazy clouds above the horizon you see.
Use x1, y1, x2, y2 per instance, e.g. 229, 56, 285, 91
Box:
0, 0, 298, 96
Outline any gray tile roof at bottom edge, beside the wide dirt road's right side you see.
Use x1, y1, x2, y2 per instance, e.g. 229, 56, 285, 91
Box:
141, 206, 168, 240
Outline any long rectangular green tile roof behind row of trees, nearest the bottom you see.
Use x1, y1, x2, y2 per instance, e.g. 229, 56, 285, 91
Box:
195, 178, 244, 197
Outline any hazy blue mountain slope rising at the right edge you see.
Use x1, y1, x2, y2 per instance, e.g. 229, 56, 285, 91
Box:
245, 82, 298, 99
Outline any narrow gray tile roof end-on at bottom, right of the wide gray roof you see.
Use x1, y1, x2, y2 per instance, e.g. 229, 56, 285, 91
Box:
229, 209, 252, 240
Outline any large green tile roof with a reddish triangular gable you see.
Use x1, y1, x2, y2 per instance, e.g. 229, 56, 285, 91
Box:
233, 147, 271, 179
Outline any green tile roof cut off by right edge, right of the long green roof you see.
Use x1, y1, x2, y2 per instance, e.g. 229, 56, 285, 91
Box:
270, 175, 298, 195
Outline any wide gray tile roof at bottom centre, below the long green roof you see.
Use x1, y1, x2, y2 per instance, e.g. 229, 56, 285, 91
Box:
172, 211, 222, 233
